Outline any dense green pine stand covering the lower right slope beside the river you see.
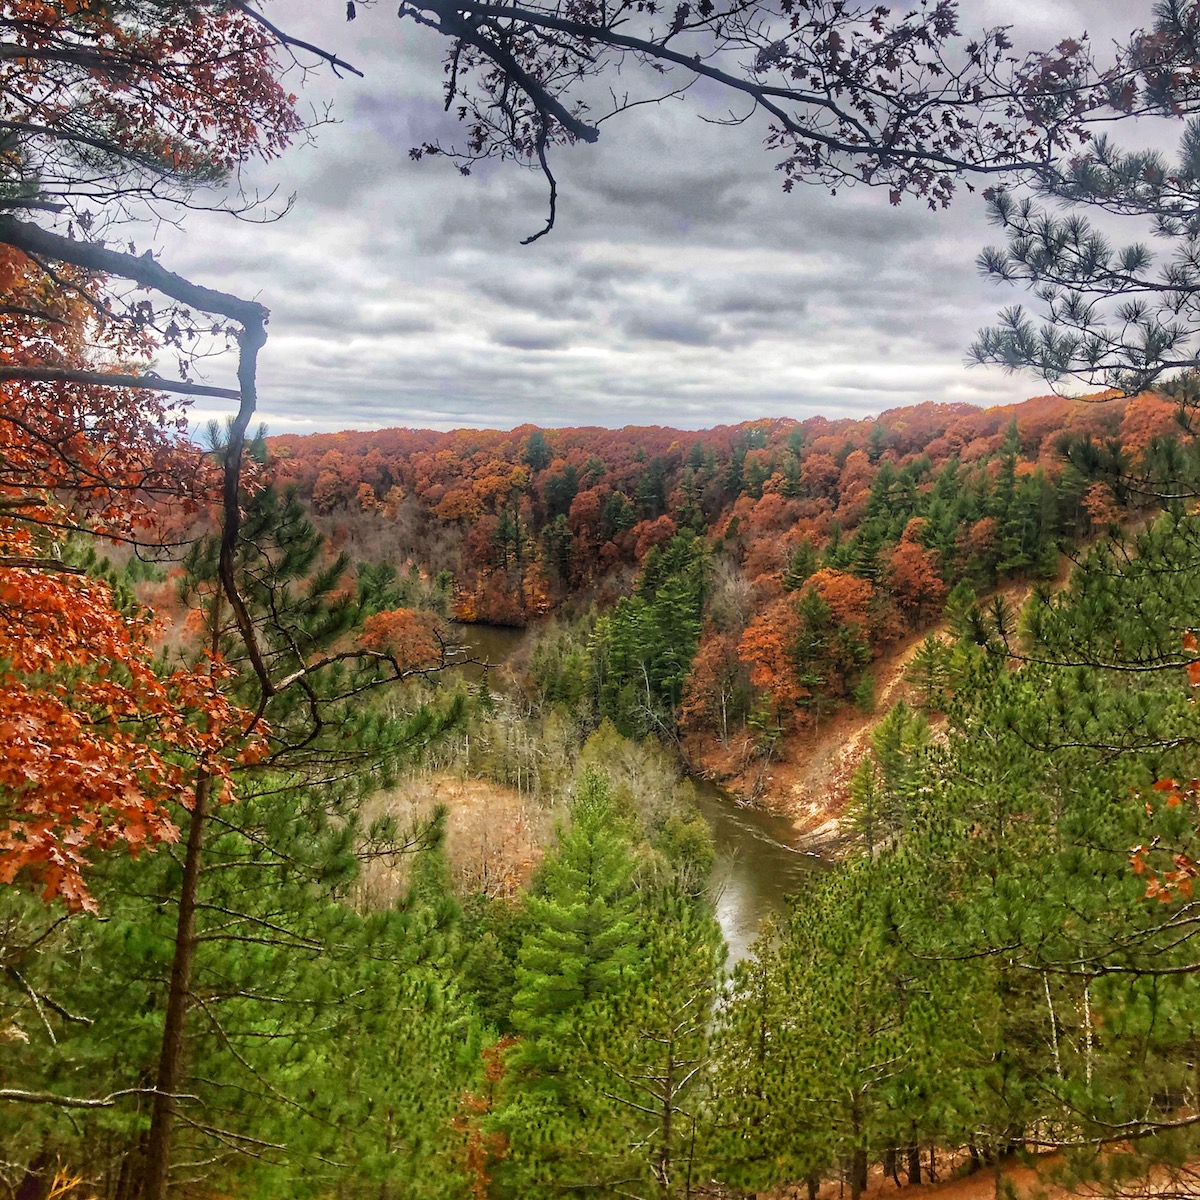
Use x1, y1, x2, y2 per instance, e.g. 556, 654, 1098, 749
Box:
713, 504, 1200, 1194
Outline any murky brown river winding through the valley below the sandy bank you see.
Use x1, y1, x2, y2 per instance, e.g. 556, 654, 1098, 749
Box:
454, 625, 821, 966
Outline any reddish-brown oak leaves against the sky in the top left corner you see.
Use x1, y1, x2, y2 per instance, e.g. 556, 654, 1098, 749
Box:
0, 0, 300, 200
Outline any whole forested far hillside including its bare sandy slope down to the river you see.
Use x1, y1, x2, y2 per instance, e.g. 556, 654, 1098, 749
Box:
269, 395, 1176, 820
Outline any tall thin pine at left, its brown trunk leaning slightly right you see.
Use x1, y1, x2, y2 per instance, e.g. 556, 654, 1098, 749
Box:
0, 487, 458, 1194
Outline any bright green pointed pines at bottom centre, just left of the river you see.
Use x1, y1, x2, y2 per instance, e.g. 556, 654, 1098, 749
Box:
493, 770, 724, 1198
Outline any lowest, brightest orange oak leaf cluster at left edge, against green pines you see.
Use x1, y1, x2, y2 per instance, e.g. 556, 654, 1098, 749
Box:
0, 561, 241, 907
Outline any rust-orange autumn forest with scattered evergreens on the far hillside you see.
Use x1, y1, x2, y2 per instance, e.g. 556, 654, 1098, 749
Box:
270, 396, 1176, 740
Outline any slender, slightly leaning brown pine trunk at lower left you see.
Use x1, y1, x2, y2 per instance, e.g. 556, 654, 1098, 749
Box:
142, 768, 212, 1200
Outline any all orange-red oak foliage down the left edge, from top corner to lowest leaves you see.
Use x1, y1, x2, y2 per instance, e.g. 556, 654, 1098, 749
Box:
0, 0, 299, 907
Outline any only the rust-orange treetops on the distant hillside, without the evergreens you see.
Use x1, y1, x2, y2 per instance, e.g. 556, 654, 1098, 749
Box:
271, 396, 1160, 744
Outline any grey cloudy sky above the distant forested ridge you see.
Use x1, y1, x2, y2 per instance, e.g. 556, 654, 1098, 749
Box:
154, 0, 1150, 433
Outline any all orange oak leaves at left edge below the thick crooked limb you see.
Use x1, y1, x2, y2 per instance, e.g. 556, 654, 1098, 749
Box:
0, 238, 242, 906
